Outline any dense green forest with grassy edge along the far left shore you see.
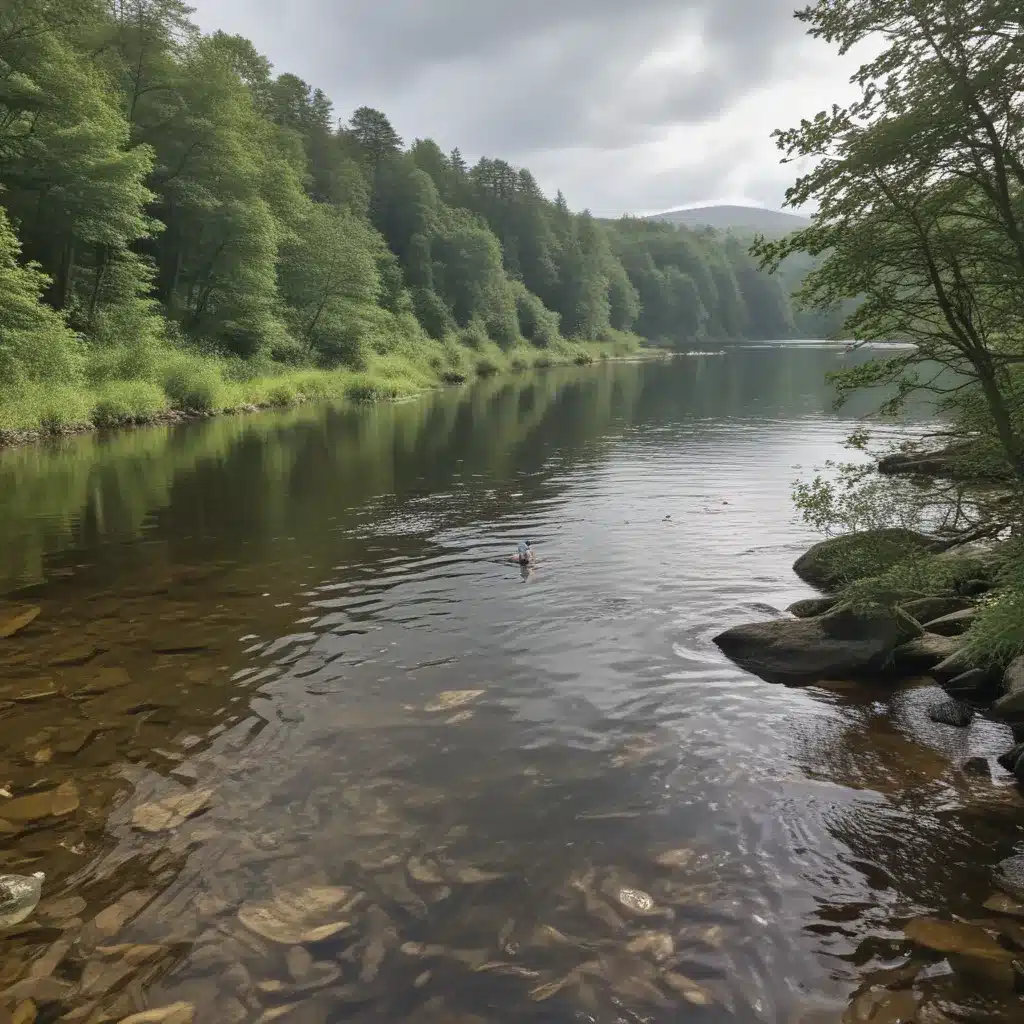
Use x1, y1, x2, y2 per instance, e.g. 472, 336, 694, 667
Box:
0, 0, 839, 431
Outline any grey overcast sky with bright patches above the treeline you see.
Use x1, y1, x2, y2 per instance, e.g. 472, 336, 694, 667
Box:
190, 0, 868, 216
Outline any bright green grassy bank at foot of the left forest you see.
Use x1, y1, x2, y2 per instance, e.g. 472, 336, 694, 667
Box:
0, 334, 640, 444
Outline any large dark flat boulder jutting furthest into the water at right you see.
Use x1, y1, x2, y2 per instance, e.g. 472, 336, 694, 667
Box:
715, 605, 921, 683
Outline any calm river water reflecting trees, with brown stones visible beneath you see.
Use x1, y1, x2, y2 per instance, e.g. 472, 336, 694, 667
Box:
0, 348, 1024, 1024
